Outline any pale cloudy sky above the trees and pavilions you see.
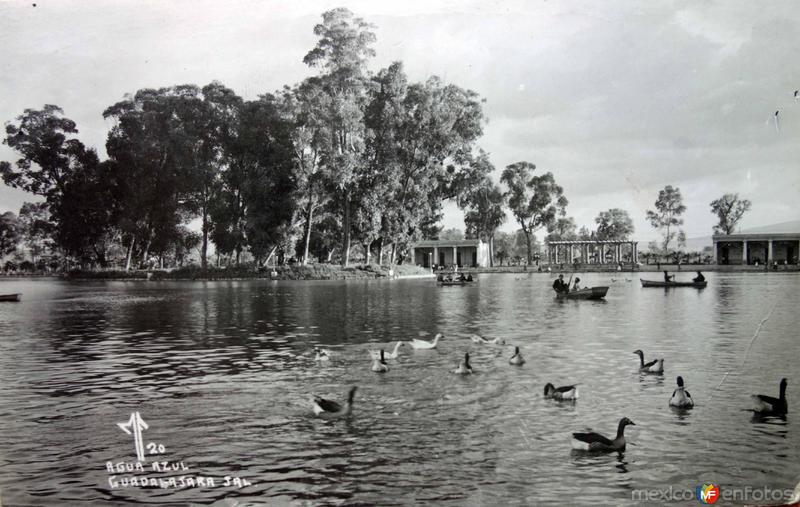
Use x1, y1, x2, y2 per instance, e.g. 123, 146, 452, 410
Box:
0, 0, 800, 241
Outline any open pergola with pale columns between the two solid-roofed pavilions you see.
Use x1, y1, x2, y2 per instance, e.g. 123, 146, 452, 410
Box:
546, 239, 639, 264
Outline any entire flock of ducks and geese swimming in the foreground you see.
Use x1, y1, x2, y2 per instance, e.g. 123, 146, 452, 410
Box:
312, 333, 788, 452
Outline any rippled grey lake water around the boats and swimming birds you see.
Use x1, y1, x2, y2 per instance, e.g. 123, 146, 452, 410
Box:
0, 273, 800, 506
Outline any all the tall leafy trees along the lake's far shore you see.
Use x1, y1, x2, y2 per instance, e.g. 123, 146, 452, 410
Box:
0, 8, 749, 269
